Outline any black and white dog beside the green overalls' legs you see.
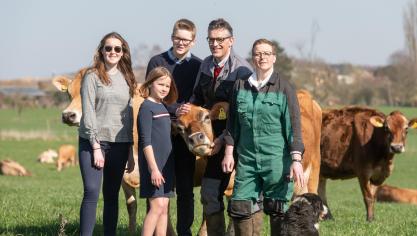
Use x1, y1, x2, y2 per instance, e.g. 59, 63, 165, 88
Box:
281, 193, 327, 236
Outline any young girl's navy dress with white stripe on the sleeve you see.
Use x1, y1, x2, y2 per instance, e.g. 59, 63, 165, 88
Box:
137, 99, 174, 198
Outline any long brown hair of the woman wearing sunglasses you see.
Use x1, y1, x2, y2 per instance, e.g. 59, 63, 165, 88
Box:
90, 32, 137, 97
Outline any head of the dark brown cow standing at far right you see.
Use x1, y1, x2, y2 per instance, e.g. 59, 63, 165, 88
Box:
369, 111, 417, 154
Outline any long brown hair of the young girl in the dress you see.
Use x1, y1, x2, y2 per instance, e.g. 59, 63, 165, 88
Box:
139, 66, 178, 105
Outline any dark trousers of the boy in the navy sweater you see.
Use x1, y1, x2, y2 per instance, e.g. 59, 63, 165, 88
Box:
172, 135, 195, 236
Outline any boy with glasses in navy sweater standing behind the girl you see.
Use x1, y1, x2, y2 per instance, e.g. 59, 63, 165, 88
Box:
146, 19, 201, 235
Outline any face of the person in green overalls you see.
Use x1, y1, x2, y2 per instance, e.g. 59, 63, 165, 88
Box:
252, 43, 277, 72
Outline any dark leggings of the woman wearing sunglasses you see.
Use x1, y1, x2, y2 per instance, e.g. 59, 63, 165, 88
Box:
78, 137, 131, 235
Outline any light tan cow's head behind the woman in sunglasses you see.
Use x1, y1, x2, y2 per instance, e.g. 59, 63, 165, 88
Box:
52, 69, 86, 126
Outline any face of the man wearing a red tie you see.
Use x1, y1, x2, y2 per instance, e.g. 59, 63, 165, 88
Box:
207, 29, 234, 62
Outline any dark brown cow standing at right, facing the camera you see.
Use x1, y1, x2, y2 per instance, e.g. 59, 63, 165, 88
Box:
319, 107, 417, 221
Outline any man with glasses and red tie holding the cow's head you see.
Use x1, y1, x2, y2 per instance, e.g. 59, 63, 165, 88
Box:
179, 19, 252, 236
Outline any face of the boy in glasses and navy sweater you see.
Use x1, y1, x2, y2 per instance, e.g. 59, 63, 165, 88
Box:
171, 29, 194, 58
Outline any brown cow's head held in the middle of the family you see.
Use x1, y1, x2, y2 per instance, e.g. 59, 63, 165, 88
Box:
173, 102, 229, 156
